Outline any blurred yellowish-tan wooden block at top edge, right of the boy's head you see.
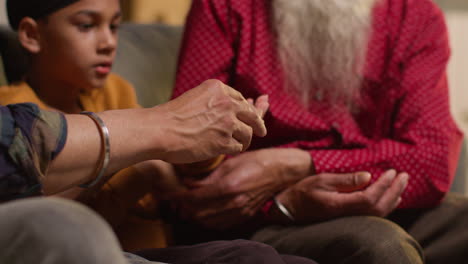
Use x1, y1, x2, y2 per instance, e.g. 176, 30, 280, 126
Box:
122, 0, 191, 25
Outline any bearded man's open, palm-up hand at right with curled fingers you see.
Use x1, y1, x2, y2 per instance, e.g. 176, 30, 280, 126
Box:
276, 170, 408, 223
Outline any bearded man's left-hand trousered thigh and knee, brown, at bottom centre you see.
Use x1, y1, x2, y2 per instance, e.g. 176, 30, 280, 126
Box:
252, 216, 422, 263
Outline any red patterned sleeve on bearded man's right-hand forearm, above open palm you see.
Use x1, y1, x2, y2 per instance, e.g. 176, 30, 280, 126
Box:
304, 136, 461, 208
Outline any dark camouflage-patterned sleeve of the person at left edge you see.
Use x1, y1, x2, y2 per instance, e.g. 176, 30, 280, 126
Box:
0, 103, 67, 201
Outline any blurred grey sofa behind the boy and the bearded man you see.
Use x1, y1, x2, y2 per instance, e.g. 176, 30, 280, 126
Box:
0, 24, 467, 193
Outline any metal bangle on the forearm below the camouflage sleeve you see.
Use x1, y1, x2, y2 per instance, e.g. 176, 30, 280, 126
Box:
79, 111, 110, 189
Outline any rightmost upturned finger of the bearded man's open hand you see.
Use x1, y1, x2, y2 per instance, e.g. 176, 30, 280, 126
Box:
376, 173, 409, 216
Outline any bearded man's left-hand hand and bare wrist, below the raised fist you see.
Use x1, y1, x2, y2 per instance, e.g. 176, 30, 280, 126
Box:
172, 149, 311, 229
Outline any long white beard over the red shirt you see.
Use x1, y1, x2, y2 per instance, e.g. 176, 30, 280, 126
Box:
273, 0, 378, 107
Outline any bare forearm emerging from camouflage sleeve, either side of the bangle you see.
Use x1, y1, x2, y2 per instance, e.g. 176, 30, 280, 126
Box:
43, 109, 164, 194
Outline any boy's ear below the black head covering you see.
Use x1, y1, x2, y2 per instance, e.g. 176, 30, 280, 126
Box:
18, 17, 41, 54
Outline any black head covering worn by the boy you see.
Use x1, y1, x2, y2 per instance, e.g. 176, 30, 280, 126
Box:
7, 0, 79, 30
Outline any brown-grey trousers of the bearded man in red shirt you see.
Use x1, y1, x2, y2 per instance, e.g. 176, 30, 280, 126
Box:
252, 194, 468, 264
